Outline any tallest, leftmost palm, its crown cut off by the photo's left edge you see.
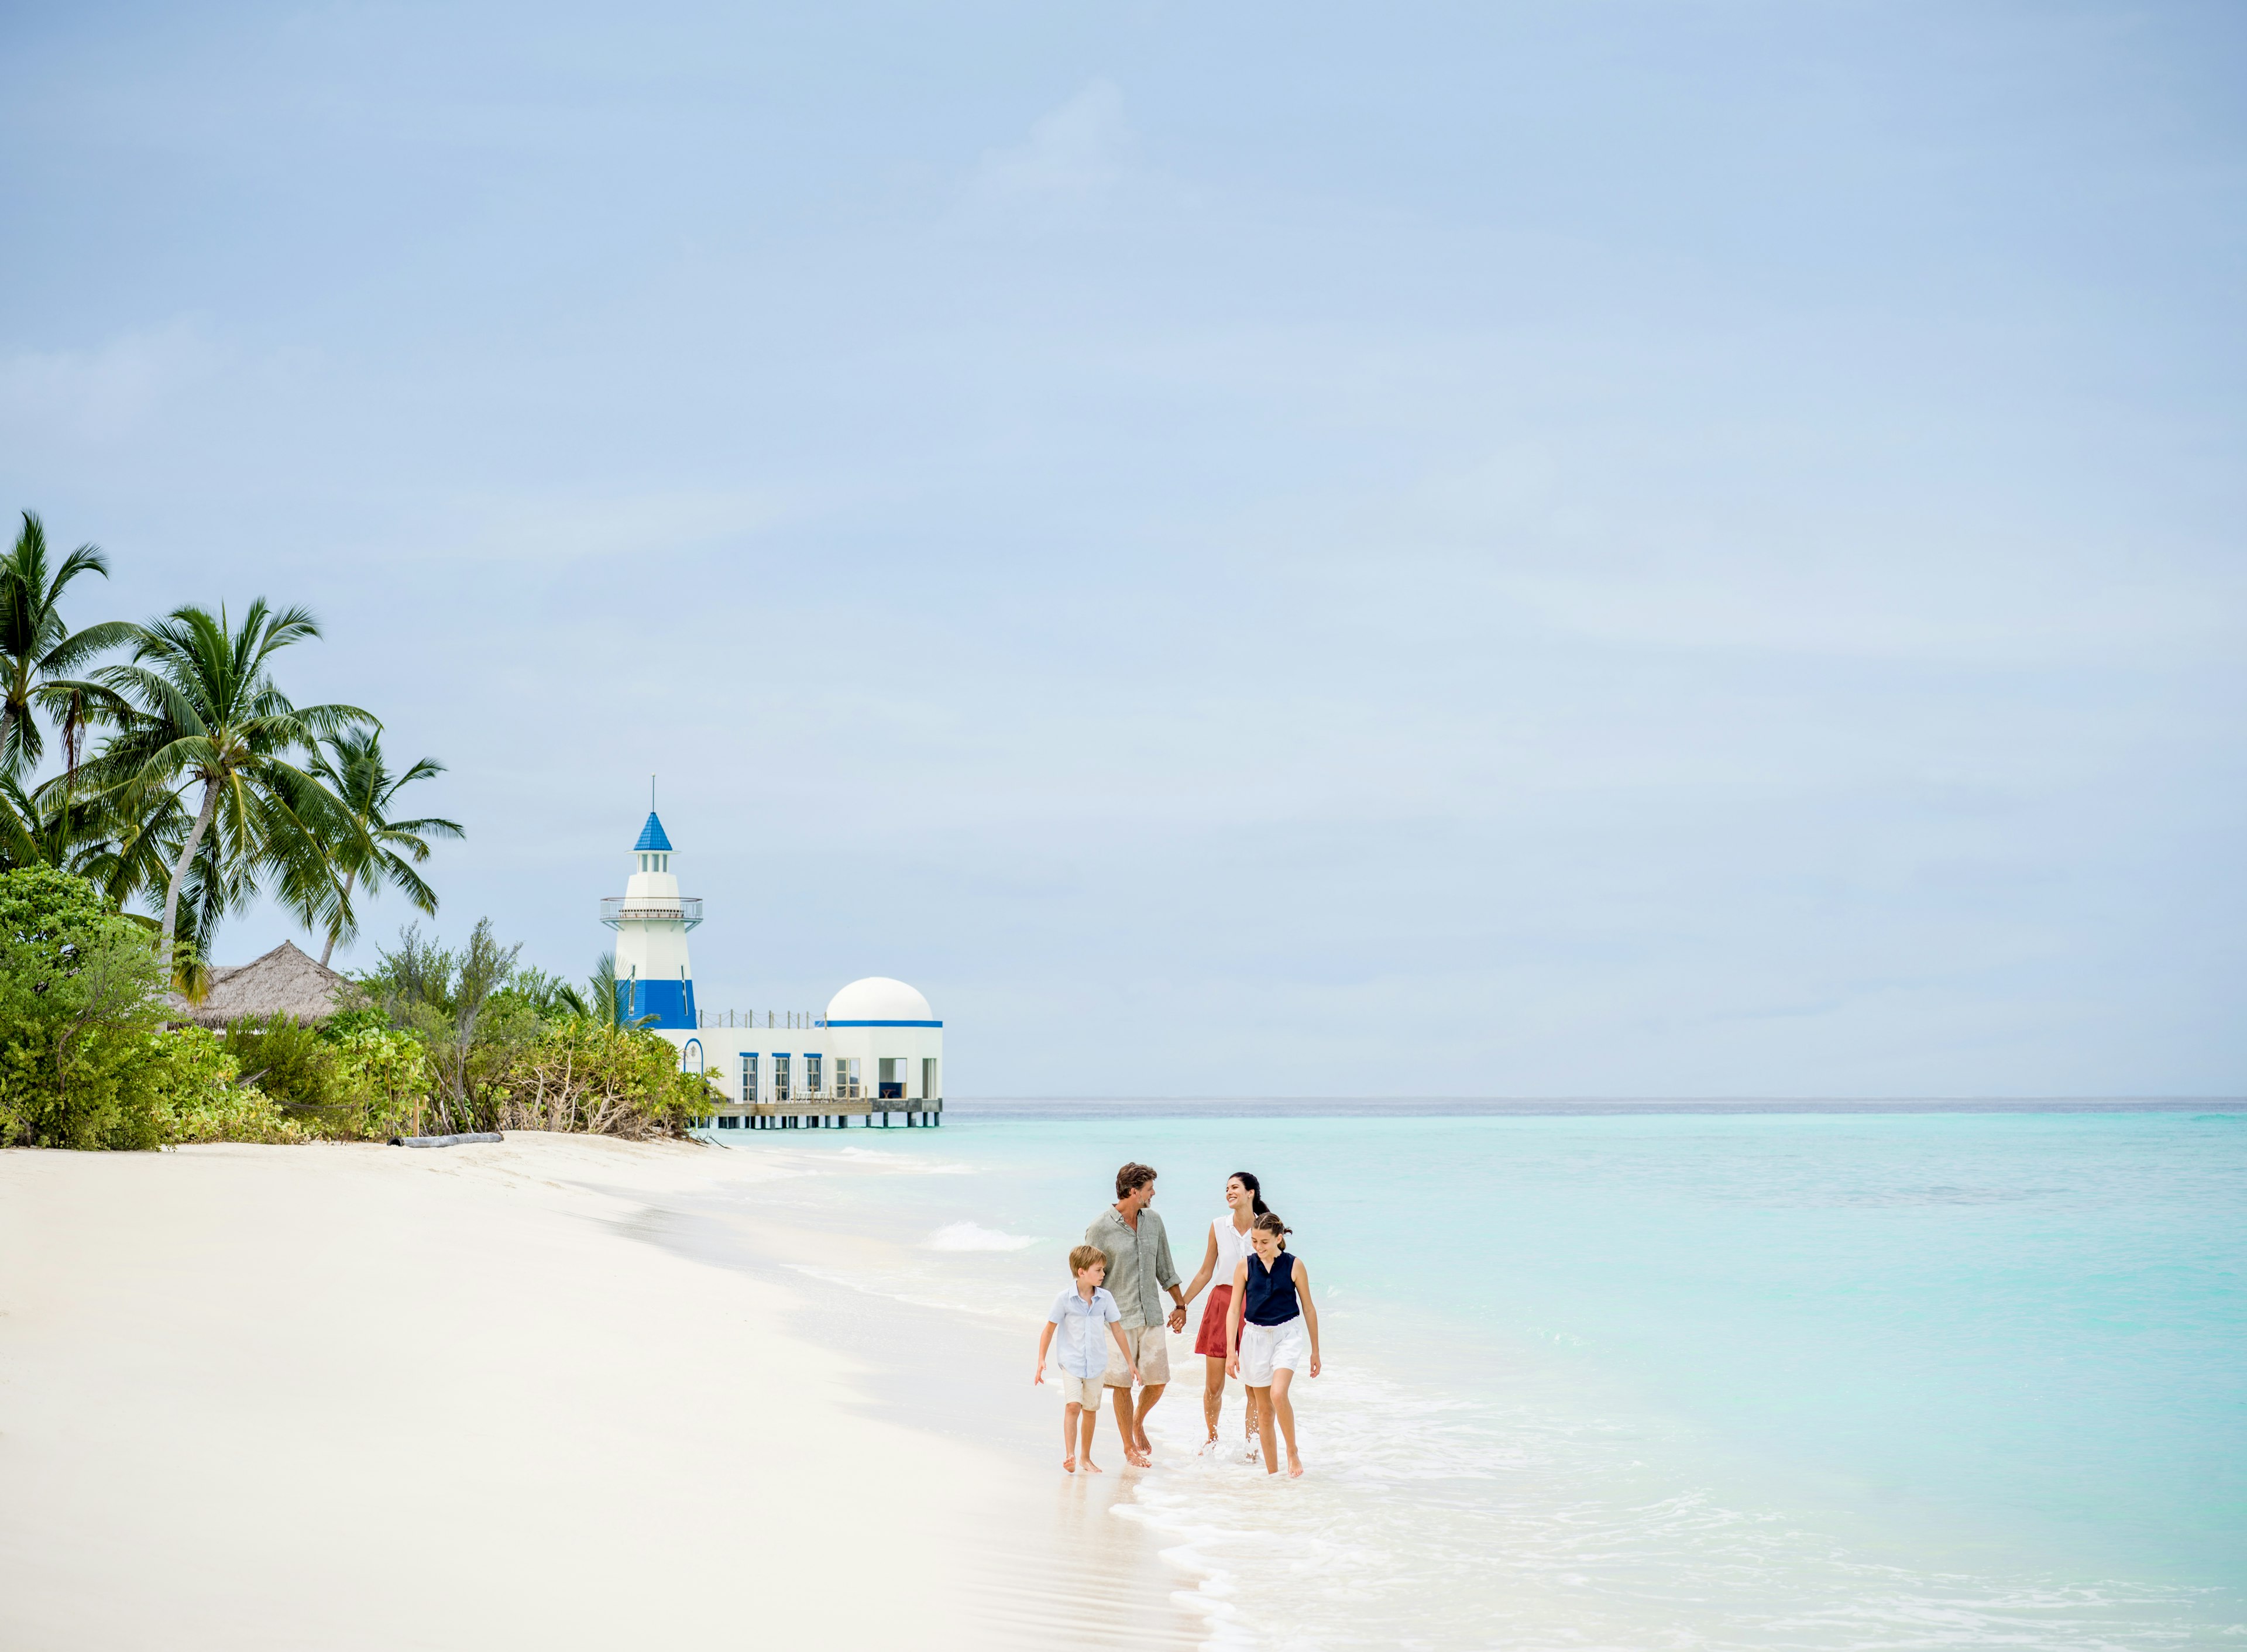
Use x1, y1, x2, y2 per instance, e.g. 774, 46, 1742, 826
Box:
0, 510, 135, 775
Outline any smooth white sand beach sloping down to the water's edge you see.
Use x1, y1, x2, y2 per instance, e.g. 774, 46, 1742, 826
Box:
0, 1135, 1186, 1652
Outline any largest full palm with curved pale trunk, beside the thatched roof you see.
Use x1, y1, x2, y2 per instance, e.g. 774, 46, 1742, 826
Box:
90, 598, 380, 957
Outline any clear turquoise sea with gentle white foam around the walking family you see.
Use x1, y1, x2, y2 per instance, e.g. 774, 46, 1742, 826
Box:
705, 1106, 2247, 1647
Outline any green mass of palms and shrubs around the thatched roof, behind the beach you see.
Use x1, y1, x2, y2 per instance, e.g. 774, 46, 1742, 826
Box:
0, 513, 710, 1149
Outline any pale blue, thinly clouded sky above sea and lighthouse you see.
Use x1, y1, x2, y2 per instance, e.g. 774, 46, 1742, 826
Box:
0, 0, 2247, 1097
